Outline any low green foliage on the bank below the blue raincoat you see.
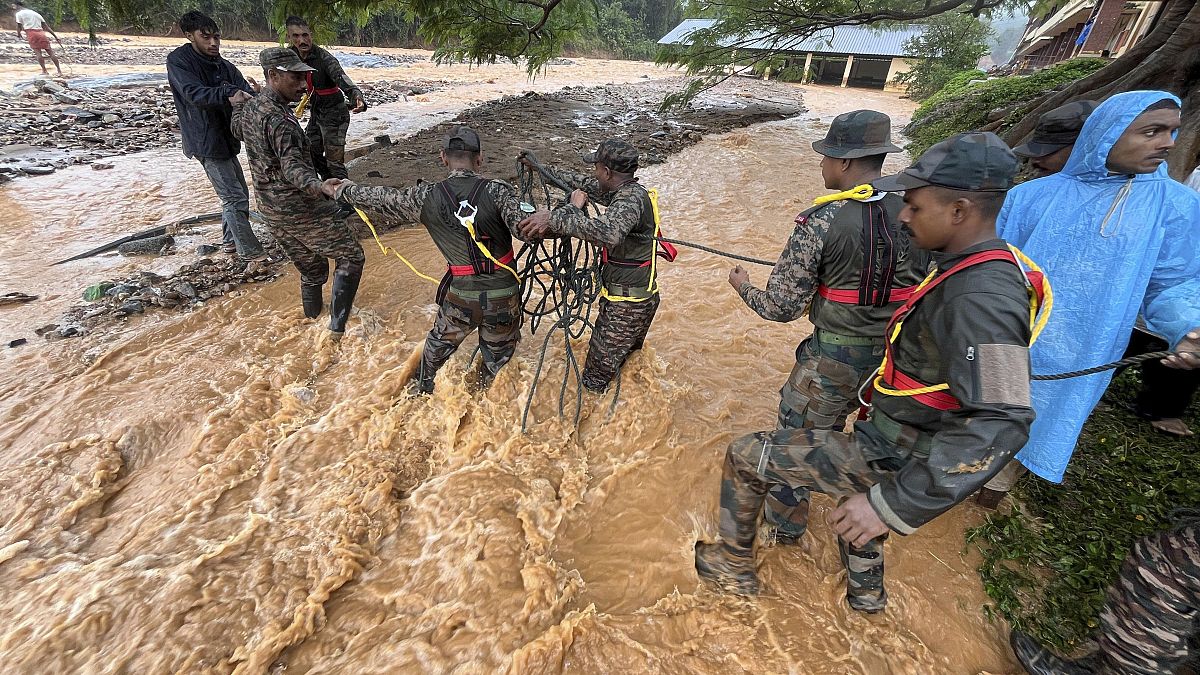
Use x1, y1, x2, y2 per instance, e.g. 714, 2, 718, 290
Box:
967, 372, 1200, 649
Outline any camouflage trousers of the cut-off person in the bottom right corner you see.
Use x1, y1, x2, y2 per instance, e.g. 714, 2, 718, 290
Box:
1097, 525, 1200, 675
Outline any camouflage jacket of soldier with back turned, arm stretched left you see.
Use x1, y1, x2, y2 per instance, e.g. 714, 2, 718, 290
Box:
337, 169, 528, 291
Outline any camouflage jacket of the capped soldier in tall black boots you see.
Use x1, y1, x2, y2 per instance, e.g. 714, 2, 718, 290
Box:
232, 86, 337, 221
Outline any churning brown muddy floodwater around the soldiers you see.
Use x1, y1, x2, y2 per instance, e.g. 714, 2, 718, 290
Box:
0, 32, 1019, 675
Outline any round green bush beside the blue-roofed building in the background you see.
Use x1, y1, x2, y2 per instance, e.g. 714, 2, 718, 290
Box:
896, 12, 992, 101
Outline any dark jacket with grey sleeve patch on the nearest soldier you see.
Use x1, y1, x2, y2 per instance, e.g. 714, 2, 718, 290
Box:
854, 239, 1033, 534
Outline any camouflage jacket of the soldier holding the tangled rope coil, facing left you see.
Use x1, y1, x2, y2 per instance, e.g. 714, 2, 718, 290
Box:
546, 167, 658, 294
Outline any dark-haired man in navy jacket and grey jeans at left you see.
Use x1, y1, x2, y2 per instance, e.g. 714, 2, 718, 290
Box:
167, 12, 263, 259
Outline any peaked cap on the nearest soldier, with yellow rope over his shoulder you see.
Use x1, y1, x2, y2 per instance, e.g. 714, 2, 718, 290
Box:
871, 131, 1016, 192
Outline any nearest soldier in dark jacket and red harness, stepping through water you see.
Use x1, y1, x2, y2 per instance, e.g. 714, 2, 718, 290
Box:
696, 133, 1033, 613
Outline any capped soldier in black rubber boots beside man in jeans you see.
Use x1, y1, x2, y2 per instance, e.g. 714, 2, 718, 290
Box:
233, 47, 366, 336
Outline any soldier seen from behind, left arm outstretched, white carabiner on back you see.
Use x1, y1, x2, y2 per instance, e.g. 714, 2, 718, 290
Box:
326, 126, 528, 394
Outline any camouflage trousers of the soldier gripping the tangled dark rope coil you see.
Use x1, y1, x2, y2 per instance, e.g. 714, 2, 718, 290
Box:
582, 293, 659, 392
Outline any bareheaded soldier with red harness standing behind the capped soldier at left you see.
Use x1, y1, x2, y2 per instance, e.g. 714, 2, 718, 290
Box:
287, 17, 367, 178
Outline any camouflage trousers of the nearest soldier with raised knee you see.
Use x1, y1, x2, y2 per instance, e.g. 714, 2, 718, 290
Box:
720, 423, 908, 611
